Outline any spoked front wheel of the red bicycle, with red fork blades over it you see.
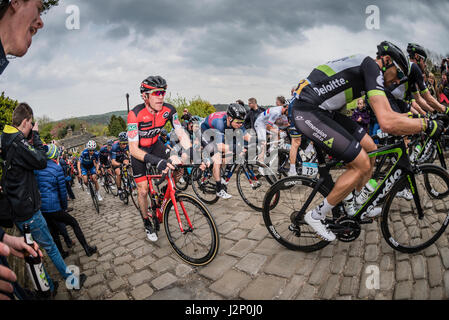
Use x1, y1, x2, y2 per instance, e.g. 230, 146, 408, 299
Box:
164, 194, 219, 266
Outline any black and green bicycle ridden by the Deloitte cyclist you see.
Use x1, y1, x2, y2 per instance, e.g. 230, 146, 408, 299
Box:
263, 136, 449, 253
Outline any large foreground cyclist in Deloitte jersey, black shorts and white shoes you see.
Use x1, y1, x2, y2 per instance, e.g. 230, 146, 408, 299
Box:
292, 41, 442, 241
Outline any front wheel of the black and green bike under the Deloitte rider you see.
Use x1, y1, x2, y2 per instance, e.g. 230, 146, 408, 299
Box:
381, 164, 449, 253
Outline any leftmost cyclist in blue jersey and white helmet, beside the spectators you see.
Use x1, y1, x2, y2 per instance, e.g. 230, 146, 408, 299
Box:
78, 140, 103, 201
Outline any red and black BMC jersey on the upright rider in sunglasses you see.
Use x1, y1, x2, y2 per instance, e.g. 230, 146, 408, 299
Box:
128, 103, 182, 148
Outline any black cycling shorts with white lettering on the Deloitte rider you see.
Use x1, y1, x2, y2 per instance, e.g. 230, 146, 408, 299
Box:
292, 100, 366, 163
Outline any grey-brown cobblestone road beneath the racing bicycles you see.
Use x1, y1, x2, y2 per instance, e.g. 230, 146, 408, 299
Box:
46, 175, 449, 300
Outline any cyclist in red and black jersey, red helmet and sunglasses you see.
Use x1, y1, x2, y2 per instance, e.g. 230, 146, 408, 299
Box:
128, 76, 191, 241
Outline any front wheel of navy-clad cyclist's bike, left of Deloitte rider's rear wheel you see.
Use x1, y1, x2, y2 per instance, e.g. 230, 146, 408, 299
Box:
236, 162, 277, 212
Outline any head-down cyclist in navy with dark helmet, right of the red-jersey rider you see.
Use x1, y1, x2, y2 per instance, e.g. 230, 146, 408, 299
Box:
201, 103, 250, 199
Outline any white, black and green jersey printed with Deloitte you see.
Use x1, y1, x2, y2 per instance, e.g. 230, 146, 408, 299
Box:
294, 55, 385, 111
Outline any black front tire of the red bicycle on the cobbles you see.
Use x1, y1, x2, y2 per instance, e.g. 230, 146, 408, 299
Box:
164, 193, 220, 266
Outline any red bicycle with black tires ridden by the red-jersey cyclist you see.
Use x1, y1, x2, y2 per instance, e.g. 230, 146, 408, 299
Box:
139, 165, 219, 266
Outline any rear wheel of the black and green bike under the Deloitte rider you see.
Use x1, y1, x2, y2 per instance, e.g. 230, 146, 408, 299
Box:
262, 176, 330, 252
